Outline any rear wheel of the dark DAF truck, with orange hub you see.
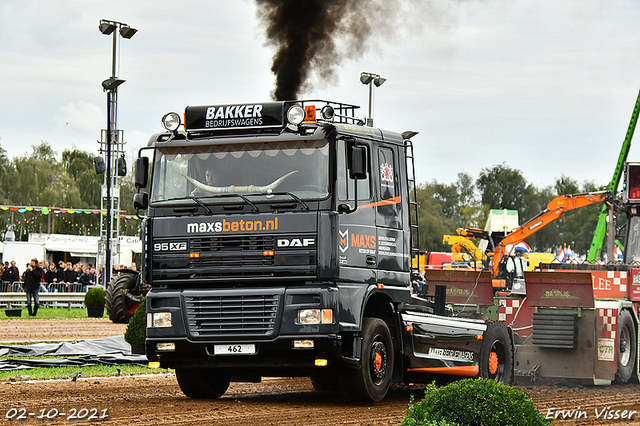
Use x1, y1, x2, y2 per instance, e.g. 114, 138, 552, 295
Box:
479, 321, 513, 385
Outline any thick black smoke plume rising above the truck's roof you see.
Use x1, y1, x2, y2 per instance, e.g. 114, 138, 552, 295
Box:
256, 0, 379, 100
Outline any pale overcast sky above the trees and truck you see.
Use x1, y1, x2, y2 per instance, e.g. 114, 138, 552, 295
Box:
0, 0, 640, 187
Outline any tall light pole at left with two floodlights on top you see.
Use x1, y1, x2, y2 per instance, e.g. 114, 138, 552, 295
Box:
96, 19, 138, 286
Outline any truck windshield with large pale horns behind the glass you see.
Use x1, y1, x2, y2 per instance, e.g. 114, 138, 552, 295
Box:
151, 140, 329, 202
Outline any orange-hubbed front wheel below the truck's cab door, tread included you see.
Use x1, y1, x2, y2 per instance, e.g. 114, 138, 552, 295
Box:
339, 317, 394, 402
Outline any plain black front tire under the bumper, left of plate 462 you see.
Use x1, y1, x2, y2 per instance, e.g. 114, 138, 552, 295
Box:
176, 368, 231, 399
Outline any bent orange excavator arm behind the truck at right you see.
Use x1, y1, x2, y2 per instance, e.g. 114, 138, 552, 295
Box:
491, 191, 610, 279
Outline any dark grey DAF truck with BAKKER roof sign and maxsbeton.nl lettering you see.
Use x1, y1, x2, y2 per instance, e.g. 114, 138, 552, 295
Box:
134, 100, 514, 401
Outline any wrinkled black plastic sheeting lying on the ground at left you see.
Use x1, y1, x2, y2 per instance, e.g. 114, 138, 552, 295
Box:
0, 335, 147, 370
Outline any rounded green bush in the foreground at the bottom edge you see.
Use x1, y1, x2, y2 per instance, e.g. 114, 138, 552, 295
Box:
402, 379, 551, 426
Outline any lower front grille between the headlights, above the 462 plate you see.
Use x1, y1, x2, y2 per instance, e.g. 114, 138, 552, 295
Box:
184, 294, 280, 338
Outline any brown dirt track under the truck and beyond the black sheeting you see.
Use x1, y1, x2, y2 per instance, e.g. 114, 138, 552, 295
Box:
0, 320, 640, 426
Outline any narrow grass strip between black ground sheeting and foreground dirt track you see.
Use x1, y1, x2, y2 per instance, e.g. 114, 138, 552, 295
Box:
0, 365, 172, 382
